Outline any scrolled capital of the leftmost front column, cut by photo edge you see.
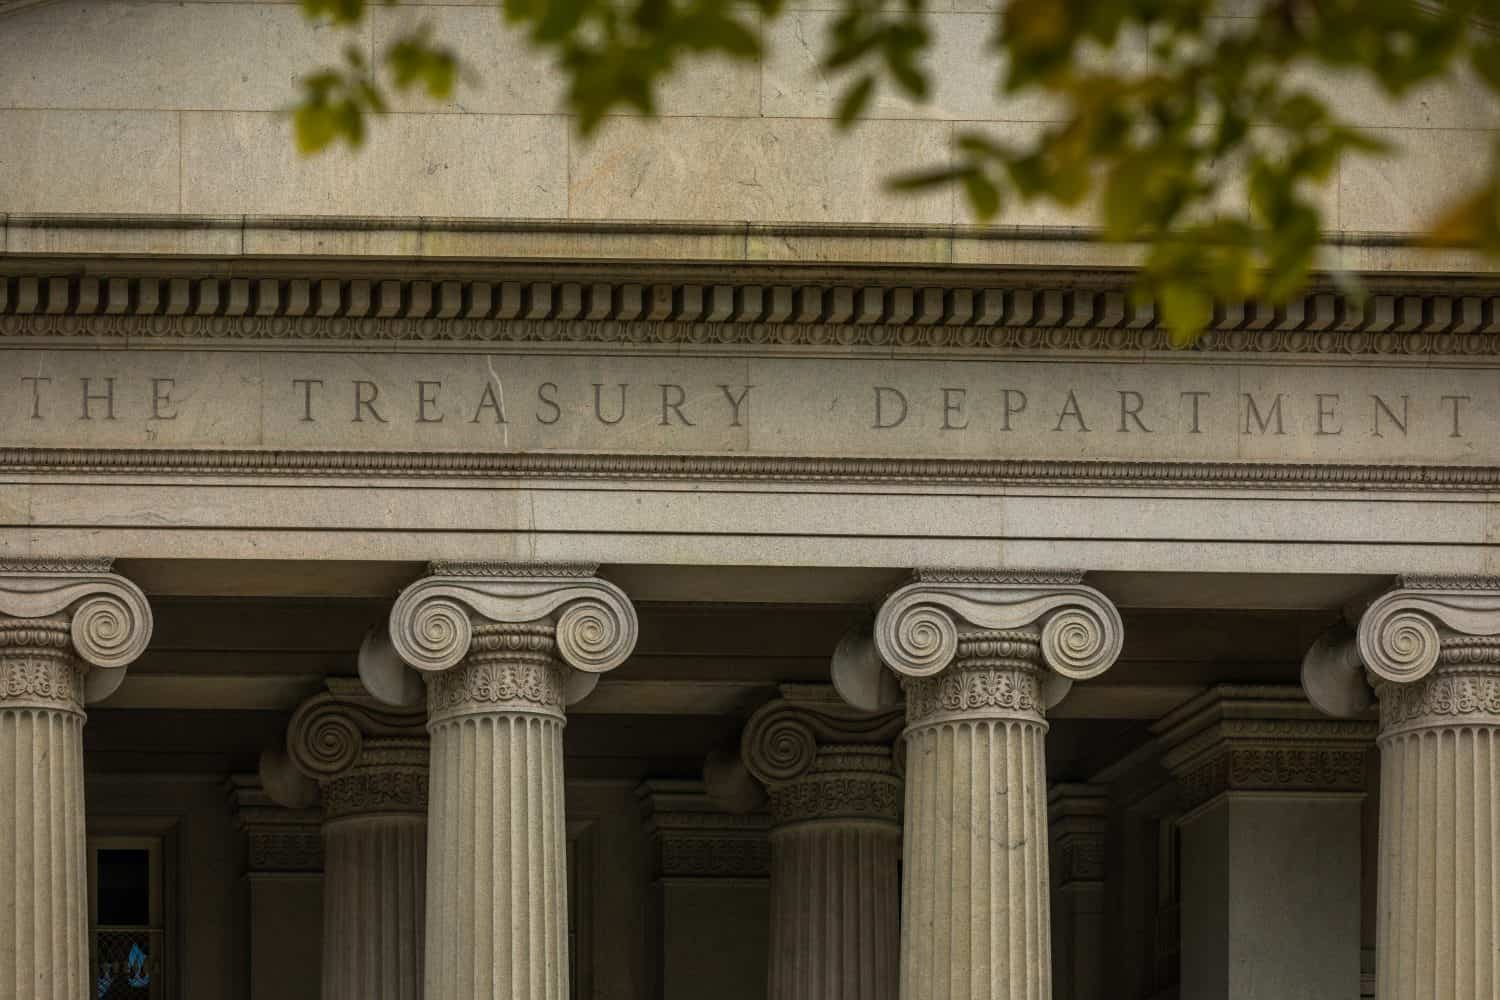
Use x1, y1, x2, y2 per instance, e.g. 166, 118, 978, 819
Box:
0, 559, 152, 700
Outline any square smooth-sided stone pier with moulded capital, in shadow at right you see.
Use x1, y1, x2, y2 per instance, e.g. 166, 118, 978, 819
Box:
1155, 685, 1376, 1000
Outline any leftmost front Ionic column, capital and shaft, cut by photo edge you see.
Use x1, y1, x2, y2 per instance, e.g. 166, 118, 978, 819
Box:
0, 559, 152, 1000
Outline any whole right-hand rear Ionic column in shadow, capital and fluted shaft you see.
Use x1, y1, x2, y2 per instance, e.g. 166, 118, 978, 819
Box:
741, 685, 902, 1000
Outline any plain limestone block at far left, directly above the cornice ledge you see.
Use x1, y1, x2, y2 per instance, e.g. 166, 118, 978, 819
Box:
0, 110, 179, 213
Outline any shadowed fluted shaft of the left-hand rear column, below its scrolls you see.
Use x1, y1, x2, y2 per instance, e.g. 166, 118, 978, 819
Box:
323, 739, 428, 1000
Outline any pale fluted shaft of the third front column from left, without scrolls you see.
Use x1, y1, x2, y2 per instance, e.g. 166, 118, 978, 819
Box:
900, 630, 1052, 1000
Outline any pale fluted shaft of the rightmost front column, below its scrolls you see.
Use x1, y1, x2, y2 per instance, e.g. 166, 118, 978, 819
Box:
1377, 656, 1500, 1000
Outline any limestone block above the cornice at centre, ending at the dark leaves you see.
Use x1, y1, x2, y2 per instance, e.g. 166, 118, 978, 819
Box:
570, 118, 953, 223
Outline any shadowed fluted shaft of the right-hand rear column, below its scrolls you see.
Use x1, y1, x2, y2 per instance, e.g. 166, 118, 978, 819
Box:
770, 747, 902, 1000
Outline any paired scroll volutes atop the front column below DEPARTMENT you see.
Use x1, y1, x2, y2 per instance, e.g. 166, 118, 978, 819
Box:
875, 570, 1125, 681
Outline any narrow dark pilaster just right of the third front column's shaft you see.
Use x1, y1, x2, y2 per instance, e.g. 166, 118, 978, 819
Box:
1047, 784, 1109, 1000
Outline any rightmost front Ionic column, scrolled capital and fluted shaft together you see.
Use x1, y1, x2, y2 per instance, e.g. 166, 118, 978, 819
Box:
1304, 577, 1500, 1000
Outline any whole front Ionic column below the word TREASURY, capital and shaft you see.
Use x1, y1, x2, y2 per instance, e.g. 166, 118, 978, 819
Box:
381, 564, 638, 1000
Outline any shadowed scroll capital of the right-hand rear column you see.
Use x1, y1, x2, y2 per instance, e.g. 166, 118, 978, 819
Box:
740, 685, 902, 826
